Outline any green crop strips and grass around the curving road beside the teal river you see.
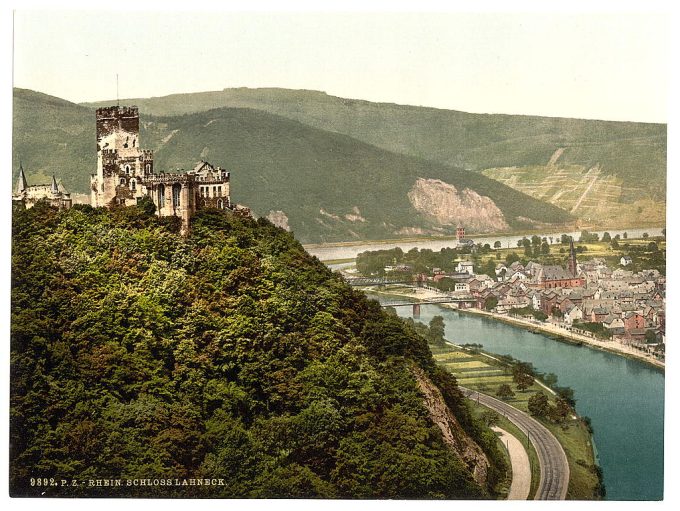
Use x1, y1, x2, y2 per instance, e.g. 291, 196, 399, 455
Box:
430, 346, 598, 499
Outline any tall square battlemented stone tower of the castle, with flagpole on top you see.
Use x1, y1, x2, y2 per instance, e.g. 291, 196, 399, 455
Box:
90, 106, 153, 207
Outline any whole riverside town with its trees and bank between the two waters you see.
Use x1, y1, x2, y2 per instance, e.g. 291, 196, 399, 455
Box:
344, 229, 666, 361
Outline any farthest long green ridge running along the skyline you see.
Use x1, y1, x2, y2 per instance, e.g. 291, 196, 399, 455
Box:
82, 88, 666, 203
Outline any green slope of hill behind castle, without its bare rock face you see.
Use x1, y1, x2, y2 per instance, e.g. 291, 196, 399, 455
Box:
14, 89, 569, 242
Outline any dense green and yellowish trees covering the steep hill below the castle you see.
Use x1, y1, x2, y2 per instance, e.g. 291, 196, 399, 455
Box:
10, 204, 503, 498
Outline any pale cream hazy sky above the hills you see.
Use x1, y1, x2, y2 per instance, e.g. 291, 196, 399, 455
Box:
14, 10, 670, 122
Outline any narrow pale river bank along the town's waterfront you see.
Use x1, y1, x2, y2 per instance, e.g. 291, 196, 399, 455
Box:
371, 288, 666, 372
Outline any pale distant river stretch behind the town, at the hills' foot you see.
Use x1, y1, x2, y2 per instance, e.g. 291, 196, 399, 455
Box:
305, 227, 662, 261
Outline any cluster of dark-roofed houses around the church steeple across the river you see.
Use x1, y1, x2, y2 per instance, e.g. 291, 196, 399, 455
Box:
410, 242, 666, 347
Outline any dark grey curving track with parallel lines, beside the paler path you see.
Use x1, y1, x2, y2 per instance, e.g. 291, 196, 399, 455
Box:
460, 387, 569, 500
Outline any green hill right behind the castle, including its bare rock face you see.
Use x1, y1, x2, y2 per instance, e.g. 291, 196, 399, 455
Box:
15, 90, 571, 242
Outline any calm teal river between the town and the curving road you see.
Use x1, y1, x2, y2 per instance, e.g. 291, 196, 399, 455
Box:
374, 295, 664, 500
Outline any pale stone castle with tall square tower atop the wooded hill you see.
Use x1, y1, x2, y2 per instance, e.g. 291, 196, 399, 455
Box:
90, 106, 239, 232
